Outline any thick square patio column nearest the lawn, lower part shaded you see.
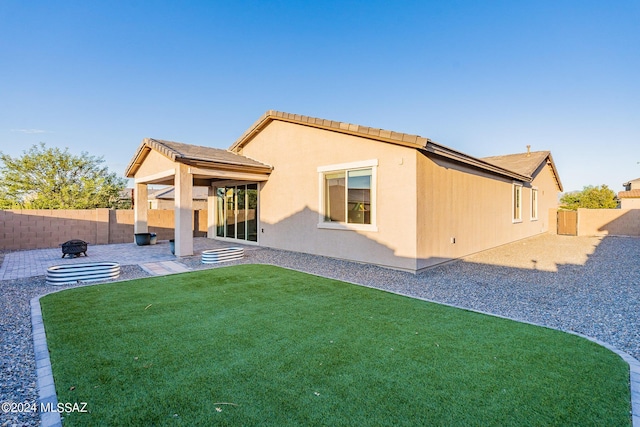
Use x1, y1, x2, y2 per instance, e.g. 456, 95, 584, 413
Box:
174, 163, 193, 257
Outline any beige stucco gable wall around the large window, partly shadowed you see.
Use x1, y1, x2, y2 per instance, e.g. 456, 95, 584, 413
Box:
241, 121, 417, 271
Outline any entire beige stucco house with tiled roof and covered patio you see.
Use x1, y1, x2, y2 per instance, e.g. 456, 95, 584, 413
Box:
126, 111, 562, 272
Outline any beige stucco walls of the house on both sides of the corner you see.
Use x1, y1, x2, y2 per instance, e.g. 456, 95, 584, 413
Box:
241, 121, 558, 271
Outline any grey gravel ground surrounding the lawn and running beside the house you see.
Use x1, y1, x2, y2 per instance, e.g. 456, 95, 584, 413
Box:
0, 235, 640, 427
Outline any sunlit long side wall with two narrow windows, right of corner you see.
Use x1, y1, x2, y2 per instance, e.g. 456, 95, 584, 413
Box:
417, 155, 558, 269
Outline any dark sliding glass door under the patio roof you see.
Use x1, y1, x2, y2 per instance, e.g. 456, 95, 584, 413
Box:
216, 184, 258, 242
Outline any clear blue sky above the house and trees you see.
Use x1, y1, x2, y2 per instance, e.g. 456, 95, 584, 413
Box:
0, 0, 640, 191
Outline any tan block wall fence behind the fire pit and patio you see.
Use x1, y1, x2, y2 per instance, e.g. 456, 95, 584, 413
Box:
0, 209, 207, 250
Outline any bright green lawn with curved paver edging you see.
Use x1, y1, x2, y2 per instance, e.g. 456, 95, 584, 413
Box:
41, 265, 630, 426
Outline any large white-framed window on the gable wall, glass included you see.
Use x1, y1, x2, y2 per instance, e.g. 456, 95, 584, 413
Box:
318, 160, 378, 230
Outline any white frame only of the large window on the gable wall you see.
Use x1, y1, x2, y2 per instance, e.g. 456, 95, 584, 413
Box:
317, 159, 378, 231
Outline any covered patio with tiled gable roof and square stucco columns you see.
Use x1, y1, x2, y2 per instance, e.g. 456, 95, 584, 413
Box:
125, 138, 272, 257
